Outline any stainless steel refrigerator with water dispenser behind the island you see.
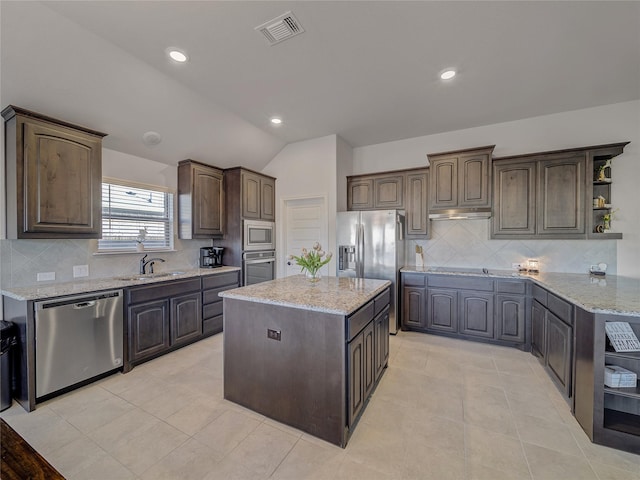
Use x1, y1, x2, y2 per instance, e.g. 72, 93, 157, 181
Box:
336, 210, 405, 334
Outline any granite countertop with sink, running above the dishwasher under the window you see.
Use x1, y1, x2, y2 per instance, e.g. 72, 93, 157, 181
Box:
0, 267, 240, 300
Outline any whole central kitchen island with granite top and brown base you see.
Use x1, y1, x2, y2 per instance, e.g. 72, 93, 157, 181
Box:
220, 275, 391, 447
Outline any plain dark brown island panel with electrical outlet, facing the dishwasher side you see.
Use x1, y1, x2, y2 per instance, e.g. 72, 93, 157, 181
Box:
224, 298, 347, 446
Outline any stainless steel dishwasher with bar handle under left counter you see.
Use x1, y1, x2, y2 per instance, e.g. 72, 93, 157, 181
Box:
35, 290, 124, 398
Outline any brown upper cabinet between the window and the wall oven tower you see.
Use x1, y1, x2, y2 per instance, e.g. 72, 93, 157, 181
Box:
178, 160, 225, 239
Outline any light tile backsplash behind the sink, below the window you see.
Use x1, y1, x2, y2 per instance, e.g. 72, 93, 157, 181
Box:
0, 239, 205, 287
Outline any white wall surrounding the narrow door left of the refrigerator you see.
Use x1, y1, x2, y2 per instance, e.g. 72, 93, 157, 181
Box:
262, 135, 346, 276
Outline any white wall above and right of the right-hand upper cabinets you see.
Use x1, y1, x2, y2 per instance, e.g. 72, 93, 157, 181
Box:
353, 101, 640, 278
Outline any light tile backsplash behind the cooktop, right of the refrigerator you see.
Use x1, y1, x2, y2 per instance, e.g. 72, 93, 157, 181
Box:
406, 219, 617, 275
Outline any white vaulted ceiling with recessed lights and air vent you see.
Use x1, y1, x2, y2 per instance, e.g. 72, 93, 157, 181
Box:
0, 0, 640, 170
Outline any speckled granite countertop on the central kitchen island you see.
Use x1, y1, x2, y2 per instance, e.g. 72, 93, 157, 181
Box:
220, 275, 391, 315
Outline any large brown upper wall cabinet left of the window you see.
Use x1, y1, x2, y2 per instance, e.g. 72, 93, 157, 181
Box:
2, 105, 106, 238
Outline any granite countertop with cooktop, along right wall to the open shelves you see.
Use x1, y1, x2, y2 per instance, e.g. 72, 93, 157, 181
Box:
400, 265, 640, 317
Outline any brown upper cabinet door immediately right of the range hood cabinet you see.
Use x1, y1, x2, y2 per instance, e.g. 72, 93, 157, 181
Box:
491, 160, 537, 238
